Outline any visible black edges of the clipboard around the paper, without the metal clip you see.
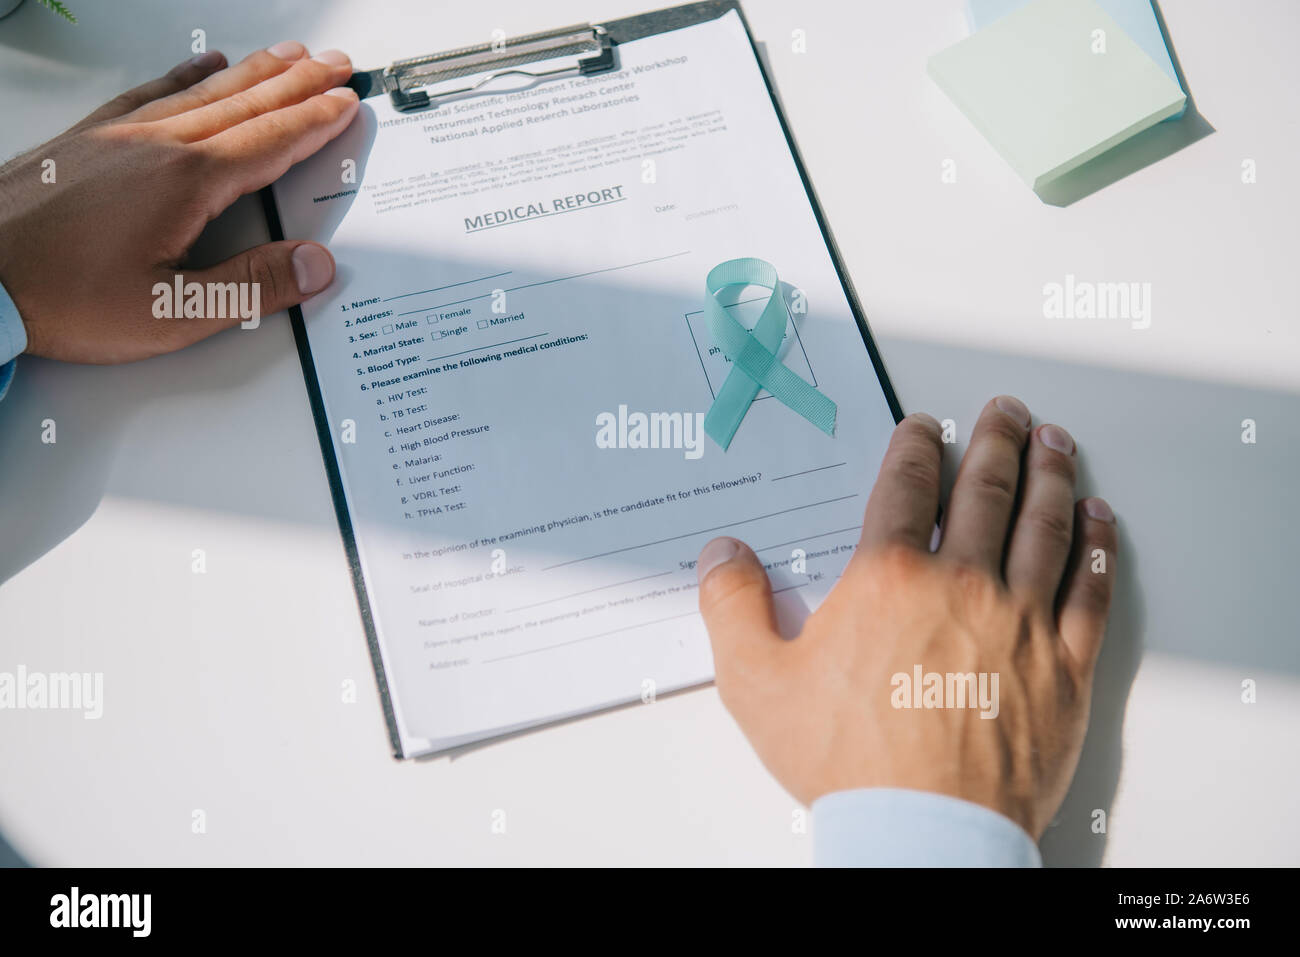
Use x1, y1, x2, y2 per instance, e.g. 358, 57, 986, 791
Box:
260, 0, 904, 759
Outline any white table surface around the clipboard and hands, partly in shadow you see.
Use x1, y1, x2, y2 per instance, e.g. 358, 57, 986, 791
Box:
0, 0, 1300, 865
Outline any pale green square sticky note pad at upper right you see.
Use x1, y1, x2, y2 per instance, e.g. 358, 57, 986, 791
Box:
928, 0, 1187, 189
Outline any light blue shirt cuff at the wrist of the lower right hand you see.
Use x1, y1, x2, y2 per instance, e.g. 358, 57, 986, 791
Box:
813, 788, 1043, 867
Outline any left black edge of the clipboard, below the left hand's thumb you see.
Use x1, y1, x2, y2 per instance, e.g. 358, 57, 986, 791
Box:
260, 186, 407, 758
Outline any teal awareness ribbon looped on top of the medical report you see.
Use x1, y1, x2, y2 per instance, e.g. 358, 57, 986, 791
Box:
705, 257, 836, 450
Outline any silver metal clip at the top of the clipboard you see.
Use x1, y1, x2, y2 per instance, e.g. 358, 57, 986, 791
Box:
350, 23, 616, 113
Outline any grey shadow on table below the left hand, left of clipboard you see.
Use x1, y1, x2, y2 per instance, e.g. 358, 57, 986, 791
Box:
0, 196, 320, 585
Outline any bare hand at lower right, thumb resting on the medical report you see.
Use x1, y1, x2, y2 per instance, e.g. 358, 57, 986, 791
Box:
698, 397, 1117, 839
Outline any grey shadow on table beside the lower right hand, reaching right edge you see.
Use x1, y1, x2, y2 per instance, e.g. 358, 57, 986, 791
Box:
430, 330, 1300, 866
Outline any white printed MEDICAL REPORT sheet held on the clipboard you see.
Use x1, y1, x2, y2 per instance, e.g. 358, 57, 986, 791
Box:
274, 12, 894, 757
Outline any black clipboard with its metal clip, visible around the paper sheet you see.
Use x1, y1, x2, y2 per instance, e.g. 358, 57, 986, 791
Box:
261, 0, 904, 759
